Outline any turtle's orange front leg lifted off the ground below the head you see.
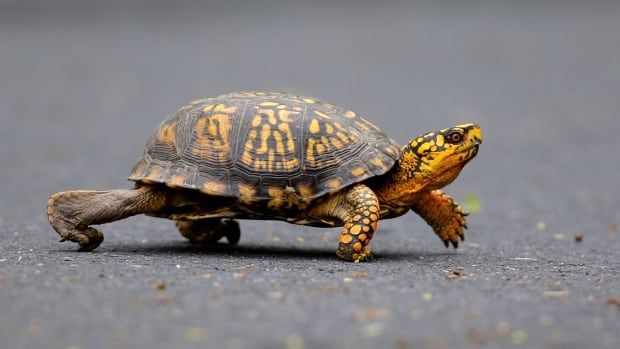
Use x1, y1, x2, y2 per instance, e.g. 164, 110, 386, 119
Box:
411, 190, 467, 248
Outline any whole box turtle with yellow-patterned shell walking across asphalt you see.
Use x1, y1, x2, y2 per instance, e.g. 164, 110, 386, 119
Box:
47, 92, 483, 262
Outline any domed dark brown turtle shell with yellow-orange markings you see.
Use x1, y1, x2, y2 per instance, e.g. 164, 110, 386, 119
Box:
129, 92, 400, 202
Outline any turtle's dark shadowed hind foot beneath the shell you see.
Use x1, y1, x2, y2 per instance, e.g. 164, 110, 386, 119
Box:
176, 218, 241, 245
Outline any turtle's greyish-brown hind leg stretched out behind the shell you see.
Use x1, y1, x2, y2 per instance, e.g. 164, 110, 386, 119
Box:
47, 186, 167, 251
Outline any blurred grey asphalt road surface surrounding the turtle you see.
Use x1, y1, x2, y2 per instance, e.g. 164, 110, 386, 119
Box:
0, 0, 620, 349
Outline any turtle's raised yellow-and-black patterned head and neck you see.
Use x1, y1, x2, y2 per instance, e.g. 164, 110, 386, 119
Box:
398, 124, 482, 193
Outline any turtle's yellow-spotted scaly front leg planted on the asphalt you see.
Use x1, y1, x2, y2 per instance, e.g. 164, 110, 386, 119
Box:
314, 184, 379, 262
